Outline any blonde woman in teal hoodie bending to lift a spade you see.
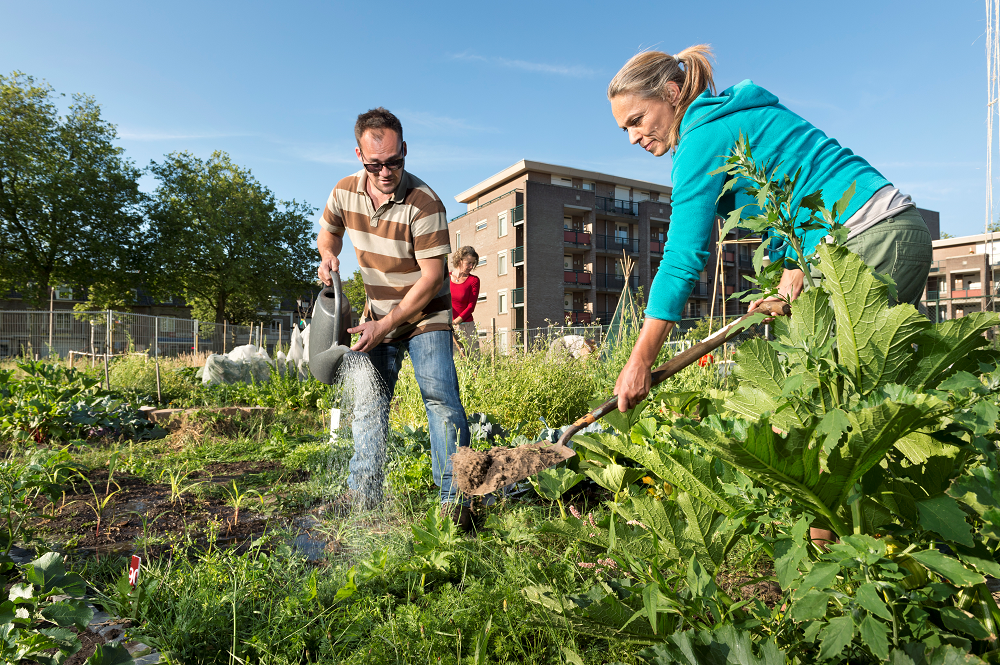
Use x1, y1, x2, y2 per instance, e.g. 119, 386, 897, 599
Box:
608, 45, 932, 411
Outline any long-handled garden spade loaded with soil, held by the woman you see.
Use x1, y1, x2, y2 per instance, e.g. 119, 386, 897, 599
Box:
451, 300, 791, 496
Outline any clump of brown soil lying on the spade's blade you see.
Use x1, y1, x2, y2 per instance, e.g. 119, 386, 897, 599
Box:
451, 441, 575, 496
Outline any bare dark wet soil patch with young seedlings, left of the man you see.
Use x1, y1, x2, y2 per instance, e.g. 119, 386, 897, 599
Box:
35, 461, 308, 556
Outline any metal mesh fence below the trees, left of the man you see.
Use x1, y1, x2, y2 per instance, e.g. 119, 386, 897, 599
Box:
0, 310, 291, 358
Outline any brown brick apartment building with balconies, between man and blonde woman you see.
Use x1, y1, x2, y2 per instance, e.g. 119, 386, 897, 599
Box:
449, 160, 755, 345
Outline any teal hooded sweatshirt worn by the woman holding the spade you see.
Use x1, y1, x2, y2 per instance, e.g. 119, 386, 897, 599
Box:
646, 80, 890, 321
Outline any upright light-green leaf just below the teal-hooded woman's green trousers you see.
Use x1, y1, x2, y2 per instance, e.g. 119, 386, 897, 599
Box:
816, 244, 930, 394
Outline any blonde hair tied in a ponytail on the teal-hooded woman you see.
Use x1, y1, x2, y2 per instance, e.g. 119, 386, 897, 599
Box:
608, 44, 715, 150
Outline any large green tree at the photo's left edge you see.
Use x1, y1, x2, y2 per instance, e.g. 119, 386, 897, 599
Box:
0, 72, 145, 305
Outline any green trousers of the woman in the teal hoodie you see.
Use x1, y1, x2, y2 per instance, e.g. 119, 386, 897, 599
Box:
845, 207, 933, 306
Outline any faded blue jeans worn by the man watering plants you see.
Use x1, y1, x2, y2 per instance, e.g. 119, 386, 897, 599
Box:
347, 330, 469, 504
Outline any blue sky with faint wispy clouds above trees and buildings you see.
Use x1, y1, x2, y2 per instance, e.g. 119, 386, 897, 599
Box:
0, 0, 984, 269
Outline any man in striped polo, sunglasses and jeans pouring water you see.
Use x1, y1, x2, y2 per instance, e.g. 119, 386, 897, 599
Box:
317, 107, 472, 531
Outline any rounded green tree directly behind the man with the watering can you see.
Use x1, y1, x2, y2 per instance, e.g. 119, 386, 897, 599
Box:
149, 152, 318, 323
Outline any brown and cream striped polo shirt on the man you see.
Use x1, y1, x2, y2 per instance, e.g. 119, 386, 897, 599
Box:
320, 169, 452, 342
